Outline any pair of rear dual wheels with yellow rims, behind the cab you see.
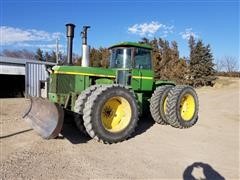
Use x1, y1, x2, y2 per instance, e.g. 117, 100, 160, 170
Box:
150, 85, 199, 128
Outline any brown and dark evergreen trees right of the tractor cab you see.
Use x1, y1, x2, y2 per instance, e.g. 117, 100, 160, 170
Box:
135, 36, 216, 87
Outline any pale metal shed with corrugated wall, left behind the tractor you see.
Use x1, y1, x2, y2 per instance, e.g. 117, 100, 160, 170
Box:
0, 56, 56, 97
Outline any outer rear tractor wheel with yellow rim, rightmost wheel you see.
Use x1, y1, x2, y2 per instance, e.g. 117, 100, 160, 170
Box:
166, 86, 199, 128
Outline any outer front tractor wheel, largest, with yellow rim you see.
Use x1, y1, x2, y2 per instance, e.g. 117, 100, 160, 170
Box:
83, 85, 138, 143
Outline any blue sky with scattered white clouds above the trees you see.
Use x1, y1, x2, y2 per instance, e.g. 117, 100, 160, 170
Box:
0, 0, 239, 58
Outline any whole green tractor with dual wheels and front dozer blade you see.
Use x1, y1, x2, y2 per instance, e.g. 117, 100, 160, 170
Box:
24, 24, 199, 143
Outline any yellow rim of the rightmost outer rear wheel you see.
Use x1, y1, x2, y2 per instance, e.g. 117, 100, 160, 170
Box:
180, 94, 195, 121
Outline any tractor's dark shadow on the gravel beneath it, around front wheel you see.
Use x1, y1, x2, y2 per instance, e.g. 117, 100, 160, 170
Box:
58, 113, 154, 144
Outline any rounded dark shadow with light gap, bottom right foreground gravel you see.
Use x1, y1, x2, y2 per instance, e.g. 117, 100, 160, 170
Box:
183, 162, 225, 180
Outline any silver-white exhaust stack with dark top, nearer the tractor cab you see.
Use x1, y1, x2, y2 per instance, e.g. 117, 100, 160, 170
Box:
81, 26, 90, 67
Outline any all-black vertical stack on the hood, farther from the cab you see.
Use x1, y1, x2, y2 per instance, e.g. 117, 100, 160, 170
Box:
66, 23, 75, 65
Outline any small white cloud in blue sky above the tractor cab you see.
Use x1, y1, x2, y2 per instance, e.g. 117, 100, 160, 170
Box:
128, 21, 174, 37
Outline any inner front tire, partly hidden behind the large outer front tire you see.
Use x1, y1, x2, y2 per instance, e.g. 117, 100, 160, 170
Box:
74, 85, 101, 134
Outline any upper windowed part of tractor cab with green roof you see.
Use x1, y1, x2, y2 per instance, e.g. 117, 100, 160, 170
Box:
109, 42, 152, 70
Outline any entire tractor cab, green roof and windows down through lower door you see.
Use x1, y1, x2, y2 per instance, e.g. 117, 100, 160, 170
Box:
109, 42, 153, 89
